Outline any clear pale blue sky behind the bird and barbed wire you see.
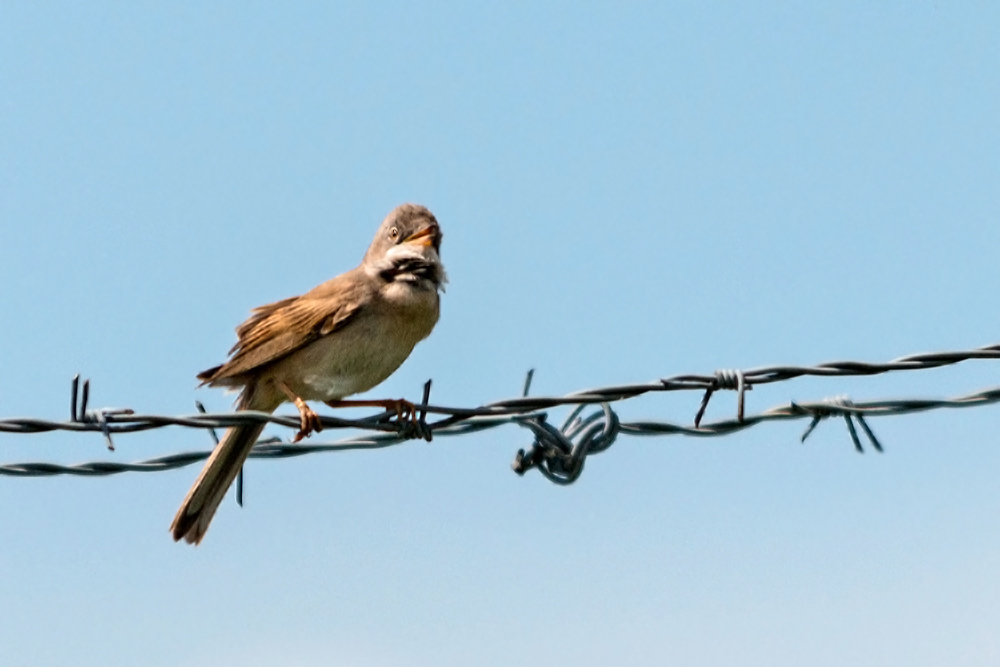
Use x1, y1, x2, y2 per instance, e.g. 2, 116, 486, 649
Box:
0, 1, 1000, 667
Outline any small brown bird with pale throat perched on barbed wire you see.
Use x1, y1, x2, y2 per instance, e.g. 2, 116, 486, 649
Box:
170, 204, 448, 544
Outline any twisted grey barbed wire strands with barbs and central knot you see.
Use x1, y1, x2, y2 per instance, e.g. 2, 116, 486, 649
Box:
0, 345, 1000, 484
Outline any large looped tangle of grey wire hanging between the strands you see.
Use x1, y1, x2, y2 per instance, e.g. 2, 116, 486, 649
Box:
511, 403, 621, 485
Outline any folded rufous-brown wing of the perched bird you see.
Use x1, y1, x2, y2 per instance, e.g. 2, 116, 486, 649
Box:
198, 269, 369, 384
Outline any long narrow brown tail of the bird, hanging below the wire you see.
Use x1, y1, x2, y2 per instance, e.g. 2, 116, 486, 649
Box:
170, 385, 281, 544
